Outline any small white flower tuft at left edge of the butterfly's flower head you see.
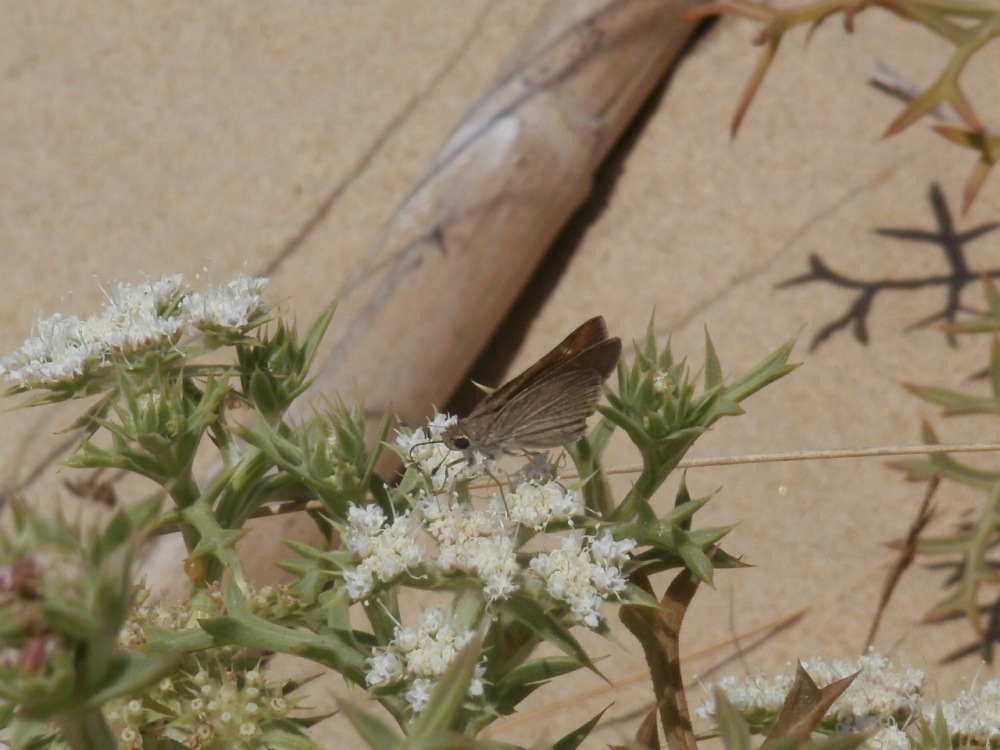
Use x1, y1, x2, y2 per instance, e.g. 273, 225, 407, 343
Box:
343, 504, 425, 601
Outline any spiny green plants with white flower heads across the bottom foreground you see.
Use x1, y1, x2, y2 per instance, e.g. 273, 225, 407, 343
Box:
0, 276, 990, 750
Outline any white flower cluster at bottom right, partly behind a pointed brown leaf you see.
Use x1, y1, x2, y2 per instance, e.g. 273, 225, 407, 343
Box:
696, 653, 925, 750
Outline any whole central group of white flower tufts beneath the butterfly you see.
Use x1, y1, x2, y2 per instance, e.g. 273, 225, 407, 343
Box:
356, 415, 635, 712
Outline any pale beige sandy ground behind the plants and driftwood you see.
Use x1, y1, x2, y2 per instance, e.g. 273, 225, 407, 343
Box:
0, 0, 1000, 747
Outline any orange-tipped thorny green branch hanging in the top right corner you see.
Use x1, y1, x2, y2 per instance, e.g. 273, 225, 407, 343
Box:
688, 0, 1000, 213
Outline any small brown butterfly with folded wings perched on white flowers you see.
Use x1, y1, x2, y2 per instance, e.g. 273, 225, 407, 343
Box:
441, 316, 622, 457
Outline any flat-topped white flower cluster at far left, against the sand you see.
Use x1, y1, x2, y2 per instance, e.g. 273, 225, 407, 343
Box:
0, 274, 267, 388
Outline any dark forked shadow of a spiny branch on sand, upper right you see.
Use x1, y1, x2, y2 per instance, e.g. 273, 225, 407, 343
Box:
777, 183, 1000, 351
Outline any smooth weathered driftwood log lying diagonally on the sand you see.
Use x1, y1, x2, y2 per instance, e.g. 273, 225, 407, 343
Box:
292, 0, 693, 422
